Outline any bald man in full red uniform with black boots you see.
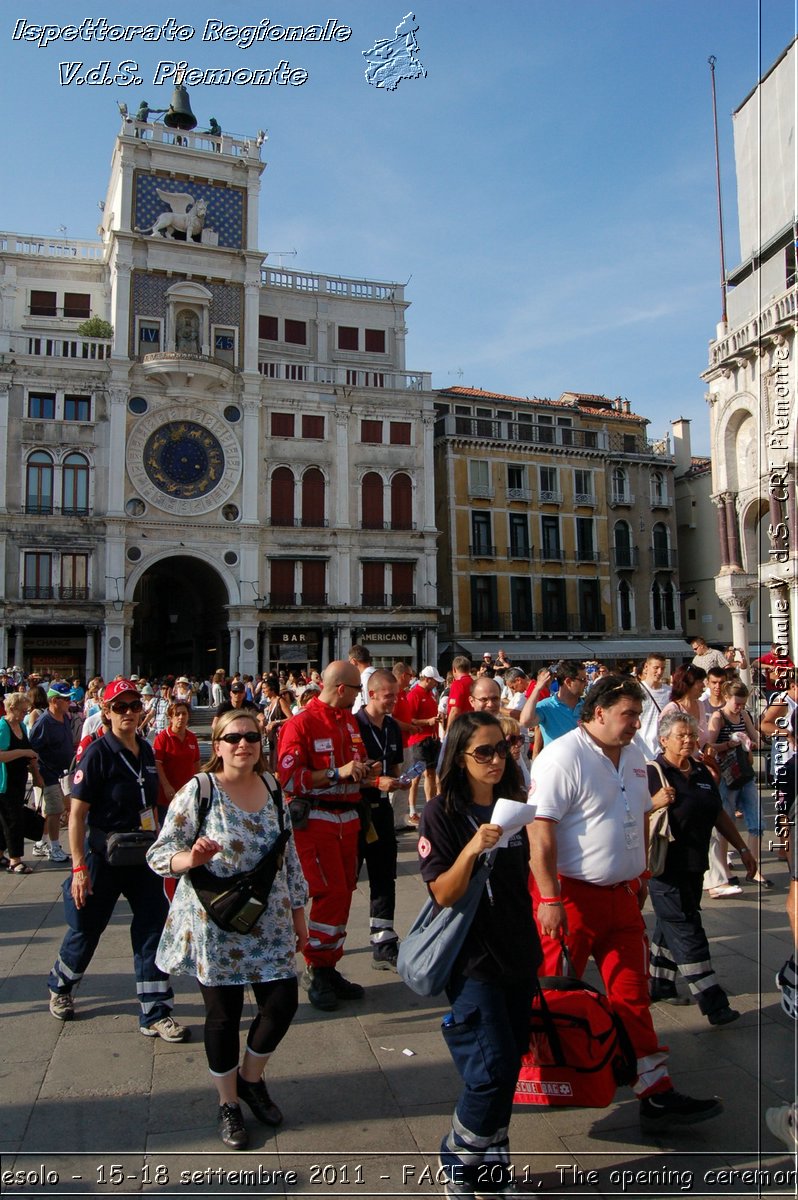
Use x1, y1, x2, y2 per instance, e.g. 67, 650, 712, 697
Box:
277, 661, 368, 1012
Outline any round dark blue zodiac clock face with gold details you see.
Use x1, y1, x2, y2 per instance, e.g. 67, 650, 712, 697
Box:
143, 421, 224, 500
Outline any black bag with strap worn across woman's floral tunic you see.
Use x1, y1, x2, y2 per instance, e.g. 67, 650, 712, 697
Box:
188, 775, 290, 934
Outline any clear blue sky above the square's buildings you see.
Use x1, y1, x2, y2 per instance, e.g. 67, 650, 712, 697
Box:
0, 0, 796, 454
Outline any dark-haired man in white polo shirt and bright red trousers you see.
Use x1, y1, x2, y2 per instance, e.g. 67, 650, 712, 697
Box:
529, 676, 722, 1133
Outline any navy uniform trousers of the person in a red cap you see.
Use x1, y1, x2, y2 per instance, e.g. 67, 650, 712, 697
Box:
48, 852, 174, 1027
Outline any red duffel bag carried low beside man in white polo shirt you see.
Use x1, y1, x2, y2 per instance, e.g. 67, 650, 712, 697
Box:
515, 976, 637, 1109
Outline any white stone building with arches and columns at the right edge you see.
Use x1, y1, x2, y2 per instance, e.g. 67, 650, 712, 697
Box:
703, 41, 798, 659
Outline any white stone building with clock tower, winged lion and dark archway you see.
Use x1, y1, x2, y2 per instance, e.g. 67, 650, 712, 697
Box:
0, 109, 438, 678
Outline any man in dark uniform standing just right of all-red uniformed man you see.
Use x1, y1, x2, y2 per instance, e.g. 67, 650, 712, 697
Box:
355, 671, 403, 971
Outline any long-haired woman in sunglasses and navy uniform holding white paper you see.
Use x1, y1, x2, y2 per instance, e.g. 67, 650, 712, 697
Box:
419, 712, 542, 1200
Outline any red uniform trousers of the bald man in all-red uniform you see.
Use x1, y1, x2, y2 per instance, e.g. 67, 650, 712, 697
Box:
294, 809, 360, 967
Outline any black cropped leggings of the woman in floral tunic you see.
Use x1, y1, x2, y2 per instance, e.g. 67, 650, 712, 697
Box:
199, 976, 299, 1075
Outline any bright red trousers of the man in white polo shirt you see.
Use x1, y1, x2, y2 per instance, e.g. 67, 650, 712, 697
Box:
533, 876, 672, 1097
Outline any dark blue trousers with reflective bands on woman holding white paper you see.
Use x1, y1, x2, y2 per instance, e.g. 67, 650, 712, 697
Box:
440, 976, 536, 1186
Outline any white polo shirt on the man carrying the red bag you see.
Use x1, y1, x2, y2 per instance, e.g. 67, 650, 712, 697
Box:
529, 728, 652, 886
